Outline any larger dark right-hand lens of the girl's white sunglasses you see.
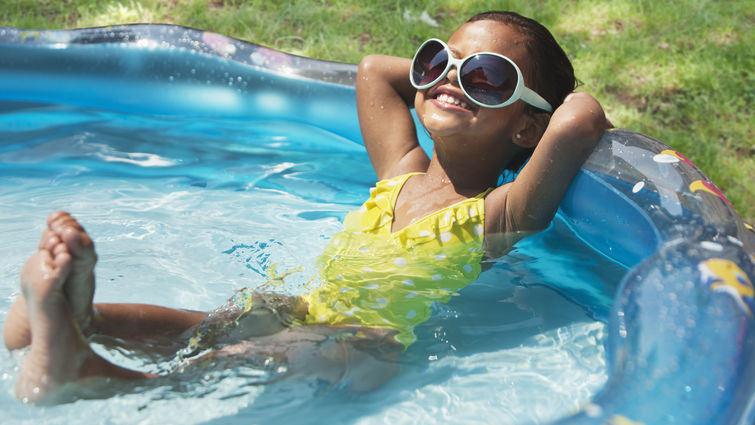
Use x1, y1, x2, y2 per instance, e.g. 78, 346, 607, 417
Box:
460, 54, 517, 105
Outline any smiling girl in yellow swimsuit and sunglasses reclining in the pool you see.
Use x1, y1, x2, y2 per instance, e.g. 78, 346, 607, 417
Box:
4, 12, 607, 401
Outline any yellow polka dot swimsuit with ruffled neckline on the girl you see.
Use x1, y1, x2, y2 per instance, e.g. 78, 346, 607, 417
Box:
304, 173, 490, 347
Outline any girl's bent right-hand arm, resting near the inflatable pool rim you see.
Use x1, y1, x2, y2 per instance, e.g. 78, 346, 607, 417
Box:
490, 93, 610, 232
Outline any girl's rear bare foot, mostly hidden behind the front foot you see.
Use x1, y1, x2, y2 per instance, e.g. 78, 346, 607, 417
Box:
3, 211, 97, 350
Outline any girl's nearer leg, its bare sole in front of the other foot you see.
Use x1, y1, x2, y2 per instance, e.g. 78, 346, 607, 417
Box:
16, 243, 402, 402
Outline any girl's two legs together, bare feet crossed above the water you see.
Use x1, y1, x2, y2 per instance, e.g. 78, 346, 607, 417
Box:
4, 213, 403, 401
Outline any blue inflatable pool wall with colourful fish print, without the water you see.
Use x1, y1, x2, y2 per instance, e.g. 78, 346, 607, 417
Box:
0, 25, 755, 425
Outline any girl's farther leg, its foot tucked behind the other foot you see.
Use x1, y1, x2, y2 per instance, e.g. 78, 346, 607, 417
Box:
3, 211, 306, 354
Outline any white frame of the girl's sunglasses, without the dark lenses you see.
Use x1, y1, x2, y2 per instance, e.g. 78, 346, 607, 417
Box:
409, 38, 553, 112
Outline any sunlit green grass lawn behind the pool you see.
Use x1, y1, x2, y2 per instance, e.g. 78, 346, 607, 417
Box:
0, 0, 755, 223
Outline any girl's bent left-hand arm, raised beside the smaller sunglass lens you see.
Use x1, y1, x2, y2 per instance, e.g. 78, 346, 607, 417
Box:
356, 55, 430, 179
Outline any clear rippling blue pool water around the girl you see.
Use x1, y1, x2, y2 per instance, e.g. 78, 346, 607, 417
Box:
0, 103, 625, 424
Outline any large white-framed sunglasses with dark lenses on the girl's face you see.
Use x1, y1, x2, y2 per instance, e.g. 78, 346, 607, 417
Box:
409, 38, 553, 112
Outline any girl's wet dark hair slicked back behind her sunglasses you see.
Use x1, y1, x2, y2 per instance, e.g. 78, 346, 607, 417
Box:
467, 11, 577, 172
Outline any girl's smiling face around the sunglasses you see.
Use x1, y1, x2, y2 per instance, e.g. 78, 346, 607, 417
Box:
414, 21, 530, 143
